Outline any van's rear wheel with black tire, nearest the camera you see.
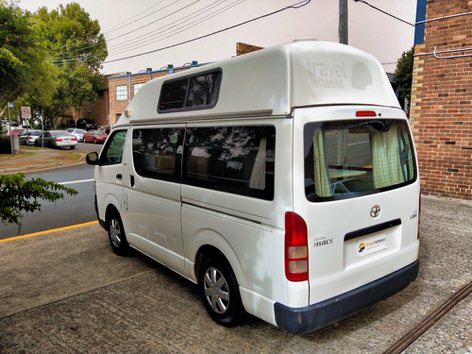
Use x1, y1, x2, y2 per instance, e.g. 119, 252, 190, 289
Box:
198, 256, 244, 327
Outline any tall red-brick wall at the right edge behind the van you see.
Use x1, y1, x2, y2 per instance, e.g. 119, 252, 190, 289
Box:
411, 0, 472, 200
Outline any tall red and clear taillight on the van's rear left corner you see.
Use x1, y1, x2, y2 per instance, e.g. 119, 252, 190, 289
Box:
285, 211, 308, 281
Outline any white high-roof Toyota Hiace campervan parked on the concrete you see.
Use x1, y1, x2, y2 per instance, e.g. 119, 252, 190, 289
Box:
87, 41, 420, 332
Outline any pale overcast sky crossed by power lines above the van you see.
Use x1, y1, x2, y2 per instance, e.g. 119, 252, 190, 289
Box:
18, 0, 416, 74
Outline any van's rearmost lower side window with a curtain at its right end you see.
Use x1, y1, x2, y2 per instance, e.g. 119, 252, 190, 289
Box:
183, 126, 275, 200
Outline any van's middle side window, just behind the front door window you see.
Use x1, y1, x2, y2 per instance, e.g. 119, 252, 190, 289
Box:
133, 128, 184, 182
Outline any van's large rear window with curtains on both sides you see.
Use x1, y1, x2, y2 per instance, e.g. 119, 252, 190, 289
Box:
304, 119, 416, 201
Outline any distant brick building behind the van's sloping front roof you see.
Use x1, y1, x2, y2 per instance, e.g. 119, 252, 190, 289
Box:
108, 61, 203, 125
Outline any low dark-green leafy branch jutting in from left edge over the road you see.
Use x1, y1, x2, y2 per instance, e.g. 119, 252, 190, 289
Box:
0, 173, 77, 224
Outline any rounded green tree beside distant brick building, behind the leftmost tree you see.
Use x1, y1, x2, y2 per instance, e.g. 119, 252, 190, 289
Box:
32, 3, 108, 124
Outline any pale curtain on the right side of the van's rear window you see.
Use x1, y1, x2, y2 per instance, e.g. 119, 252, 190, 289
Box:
371, 125, 405, 188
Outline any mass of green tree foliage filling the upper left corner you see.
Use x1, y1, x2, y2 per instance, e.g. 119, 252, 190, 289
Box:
0, 0, 108, 124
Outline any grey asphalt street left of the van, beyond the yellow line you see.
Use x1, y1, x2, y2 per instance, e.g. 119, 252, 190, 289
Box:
0, 144, 102, 238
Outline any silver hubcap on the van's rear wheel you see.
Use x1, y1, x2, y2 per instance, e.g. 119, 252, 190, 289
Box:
203, 267, 230, 314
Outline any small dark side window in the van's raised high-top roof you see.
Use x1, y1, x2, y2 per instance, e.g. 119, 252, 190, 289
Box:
157, 69, 221, 112
